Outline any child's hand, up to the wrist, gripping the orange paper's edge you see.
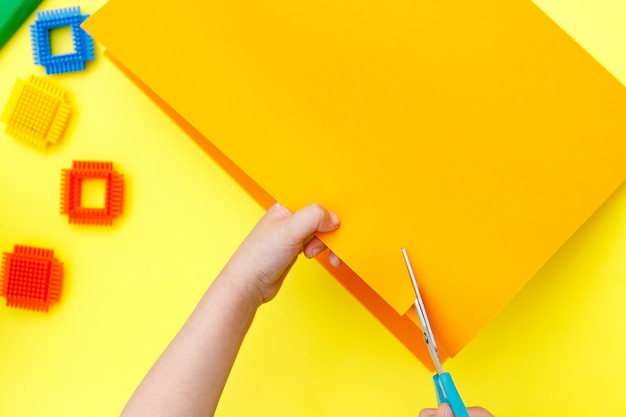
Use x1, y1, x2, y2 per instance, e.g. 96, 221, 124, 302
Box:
225, 203, 340, 305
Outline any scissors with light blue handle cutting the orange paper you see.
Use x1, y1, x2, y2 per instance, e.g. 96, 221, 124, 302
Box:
402, 248, 469, 417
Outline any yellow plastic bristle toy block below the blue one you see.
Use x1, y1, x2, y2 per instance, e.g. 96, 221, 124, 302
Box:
2, 75, 71, 148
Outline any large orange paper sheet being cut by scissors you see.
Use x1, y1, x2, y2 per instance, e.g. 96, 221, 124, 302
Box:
84, 0, 626, 361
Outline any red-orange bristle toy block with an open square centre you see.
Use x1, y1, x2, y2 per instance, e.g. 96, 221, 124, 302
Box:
61, 161, 124, 226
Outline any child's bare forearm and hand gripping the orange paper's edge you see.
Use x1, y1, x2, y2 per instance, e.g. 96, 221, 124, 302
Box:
122, 200, 339, 417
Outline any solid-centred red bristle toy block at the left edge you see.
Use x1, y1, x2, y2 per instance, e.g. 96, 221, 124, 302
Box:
0, 245, 63, 312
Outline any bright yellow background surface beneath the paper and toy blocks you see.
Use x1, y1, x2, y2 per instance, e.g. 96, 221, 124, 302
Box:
0, 0, 626, 417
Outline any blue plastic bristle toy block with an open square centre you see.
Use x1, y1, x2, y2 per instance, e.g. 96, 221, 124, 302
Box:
30, 7, 95, 74
